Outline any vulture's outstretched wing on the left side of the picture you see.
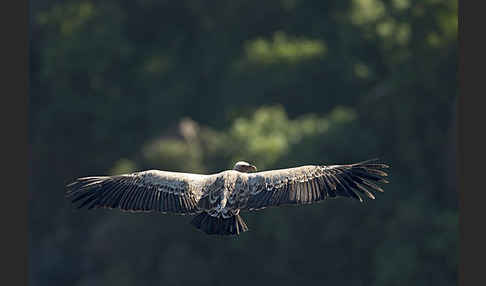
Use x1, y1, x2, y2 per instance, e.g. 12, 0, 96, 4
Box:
66, 170, 207, 214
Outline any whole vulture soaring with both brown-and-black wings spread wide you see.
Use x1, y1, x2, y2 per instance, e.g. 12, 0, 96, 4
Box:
66, 159, 388, 235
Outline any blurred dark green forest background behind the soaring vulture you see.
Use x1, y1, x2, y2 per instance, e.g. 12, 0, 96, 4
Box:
29, 0, 458, 285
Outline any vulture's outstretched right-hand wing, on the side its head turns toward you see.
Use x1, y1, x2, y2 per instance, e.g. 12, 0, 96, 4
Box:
245, 160, 388, 210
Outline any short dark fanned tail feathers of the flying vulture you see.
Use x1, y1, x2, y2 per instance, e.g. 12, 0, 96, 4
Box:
191, 212, 248, 235
